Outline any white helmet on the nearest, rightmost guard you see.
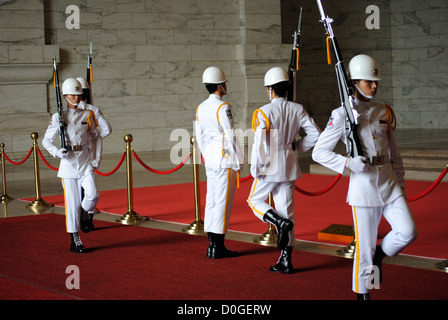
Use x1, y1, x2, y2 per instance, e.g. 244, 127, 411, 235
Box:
348, 54, 381, 81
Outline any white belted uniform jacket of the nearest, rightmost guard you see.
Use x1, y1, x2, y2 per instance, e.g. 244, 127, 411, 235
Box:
312, 99, 405, 207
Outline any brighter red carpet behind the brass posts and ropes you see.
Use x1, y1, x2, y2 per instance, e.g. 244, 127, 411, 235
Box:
24, 174, 448, 259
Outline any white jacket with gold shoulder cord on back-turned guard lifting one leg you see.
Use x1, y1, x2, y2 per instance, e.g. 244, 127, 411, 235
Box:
251, 98, 320, 182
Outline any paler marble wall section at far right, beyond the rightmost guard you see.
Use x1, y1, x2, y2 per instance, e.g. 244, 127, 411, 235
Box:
390, 0, 448, 129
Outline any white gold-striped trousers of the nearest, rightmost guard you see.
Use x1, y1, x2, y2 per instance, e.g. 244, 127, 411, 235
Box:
352, 196, 417, 293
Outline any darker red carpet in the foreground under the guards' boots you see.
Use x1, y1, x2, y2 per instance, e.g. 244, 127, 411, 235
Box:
0, 214, 448, 302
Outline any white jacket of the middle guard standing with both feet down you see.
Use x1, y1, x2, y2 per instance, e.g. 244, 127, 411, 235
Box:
195, 94, 244, 171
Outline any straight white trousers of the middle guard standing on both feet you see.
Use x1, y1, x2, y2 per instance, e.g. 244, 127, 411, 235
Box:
204, 167, 236, 234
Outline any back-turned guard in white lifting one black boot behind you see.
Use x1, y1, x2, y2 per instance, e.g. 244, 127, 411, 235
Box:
247, 67, 320, 273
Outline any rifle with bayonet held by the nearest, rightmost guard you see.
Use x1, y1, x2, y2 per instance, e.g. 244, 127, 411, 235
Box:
316, 0, 362, 158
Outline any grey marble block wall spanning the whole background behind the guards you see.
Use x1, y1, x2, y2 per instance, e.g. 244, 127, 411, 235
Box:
0, 0, 448, 158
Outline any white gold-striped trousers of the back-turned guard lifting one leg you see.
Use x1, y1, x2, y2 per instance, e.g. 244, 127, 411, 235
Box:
247, 179, 295, 246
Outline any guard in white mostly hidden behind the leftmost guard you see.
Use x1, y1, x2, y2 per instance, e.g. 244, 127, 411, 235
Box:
76, 77, 112, 230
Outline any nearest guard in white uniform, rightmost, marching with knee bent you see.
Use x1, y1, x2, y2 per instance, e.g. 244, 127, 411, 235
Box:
312, 55, 417, 300
